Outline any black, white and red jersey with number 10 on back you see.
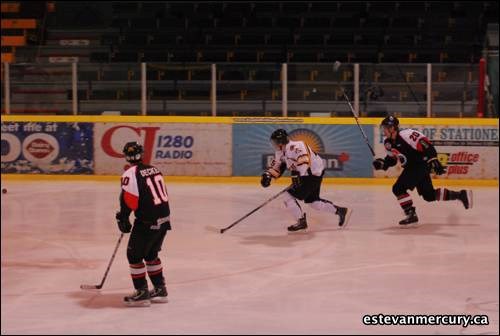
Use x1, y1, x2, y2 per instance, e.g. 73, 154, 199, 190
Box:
120, 163, 170, 229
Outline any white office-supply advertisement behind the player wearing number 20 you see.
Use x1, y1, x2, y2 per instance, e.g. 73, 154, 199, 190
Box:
374, 125, 498, 179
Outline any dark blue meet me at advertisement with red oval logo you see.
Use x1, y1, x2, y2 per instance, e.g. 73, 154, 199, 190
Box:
2, 122, 94, 174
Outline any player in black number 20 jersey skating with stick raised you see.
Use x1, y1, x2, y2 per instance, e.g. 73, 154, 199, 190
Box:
373, 116, 472, 225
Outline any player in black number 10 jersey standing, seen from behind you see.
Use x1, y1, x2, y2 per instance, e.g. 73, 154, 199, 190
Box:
116, 142, 171, 306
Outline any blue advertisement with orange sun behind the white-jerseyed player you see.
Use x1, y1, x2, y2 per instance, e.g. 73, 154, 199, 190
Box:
233, 124, 373, 177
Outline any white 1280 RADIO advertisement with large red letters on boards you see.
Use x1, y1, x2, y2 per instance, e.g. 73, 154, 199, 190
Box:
94, 123, 231, 176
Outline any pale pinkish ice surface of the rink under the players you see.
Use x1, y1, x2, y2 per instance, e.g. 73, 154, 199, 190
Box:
1, 178, 499, 335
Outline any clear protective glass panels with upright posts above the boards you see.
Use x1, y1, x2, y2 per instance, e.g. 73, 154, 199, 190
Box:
2, 63, 497, 117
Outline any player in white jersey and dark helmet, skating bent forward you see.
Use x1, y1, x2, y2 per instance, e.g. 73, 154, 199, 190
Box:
261, 129, 351, 231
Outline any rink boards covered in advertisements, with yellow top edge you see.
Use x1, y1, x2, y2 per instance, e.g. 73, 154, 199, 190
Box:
1, 116, 498, 185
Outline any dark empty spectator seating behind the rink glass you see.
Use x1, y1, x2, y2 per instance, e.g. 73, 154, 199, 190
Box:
2, 1, 498, 116
